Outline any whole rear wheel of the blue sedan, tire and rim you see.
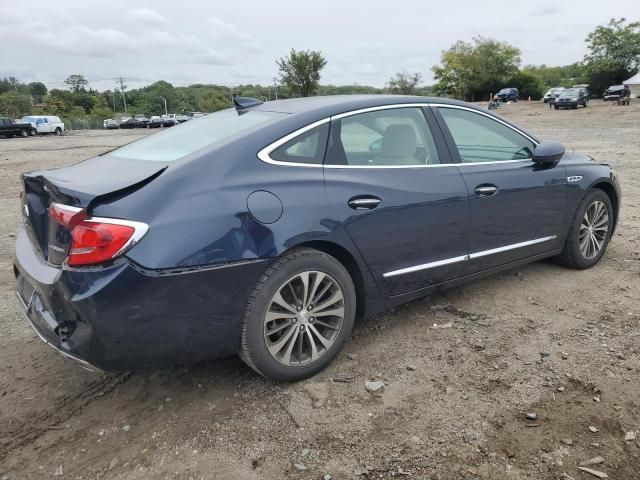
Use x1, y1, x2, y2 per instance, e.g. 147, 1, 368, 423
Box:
240, 248, 356, 382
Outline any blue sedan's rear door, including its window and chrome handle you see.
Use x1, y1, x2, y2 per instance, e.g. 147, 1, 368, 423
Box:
324, 106, 469, 295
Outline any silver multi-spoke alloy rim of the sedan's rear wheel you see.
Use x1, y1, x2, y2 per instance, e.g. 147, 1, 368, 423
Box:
264, 271, 345, 367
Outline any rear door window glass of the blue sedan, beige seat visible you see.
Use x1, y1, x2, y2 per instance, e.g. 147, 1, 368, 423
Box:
326, 107, 439, 167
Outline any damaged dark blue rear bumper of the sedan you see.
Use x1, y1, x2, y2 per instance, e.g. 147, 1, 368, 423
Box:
14, 230, 266, 370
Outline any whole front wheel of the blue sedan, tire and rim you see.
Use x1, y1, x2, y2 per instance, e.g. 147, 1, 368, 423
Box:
556, 189, 613, 270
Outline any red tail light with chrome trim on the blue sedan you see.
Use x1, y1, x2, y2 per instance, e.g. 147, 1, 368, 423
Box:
49, 204, 149, 266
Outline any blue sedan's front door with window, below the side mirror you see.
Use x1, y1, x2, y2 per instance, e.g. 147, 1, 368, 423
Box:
434, 105, 568, 273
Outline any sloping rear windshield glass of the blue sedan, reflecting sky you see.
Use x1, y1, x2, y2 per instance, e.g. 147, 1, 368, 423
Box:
110, 109, 287, 162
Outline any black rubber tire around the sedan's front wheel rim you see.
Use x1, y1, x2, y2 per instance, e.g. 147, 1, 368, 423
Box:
554, 188, 614, 270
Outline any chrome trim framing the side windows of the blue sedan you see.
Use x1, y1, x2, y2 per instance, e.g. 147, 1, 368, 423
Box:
258, 103, 538, 169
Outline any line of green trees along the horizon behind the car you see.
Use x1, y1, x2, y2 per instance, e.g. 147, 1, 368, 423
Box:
0, 18, 640, 126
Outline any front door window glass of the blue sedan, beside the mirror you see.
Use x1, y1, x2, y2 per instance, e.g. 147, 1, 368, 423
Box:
439, 107, 535, 163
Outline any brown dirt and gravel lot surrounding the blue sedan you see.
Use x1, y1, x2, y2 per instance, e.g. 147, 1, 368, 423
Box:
0, 101, 640, 480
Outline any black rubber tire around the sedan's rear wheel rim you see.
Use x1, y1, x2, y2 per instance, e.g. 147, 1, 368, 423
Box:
239, 248, 356, 382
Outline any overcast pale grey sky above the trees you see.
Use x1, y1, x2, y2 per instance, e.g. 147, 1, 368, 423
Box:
0, 0, 640, 90
